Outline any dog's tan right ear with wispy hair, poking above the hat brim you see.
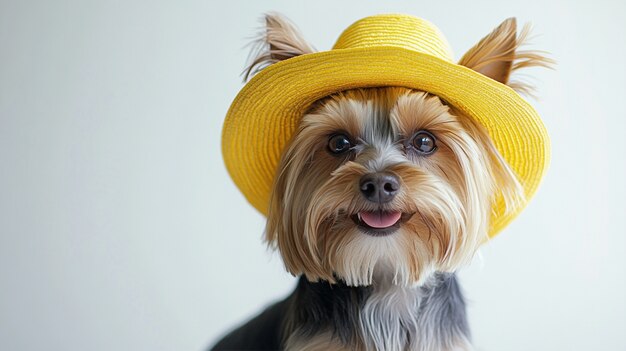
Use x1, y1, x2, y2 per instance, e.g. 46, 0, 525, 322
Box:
459, 18, 554, 93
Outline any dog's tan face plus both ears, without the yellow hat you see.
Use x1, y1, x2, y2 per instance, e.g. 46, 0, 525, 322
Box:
248, 16, 545, 285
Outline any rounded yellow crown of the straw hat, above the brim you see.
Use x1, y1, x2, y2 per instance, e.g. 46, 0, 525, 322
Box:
333, 14, 452, 62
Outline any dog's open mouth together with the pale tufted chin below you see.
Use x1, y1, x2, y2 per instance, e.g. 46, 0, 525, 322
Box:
324, 212, 434, 286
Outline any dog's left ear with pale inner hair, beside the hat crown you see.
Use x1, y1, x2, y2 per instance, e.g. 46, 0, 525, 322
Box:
244, 13, 315, 81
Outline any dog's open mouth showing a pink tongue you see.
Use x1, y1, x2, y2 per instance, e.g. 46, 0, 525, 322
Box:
350, 210, 413, 236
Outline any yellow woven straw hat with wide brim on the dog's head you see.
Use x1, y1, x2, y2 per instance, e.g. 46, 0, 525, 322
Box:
222, 14, 550, 236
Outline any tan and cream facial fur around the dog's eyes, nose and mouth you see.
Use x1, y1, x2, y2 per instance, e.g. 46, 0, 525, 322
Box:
266, 88, 522, 285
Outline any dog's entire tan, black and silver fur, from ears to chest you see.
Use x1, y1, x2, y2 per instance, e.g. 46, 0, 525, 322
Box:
214, 15, 550, 350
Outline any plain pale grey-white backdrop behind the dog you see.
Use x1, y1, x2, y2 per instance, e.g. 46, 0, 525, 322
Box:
0, 0, 626, 351
